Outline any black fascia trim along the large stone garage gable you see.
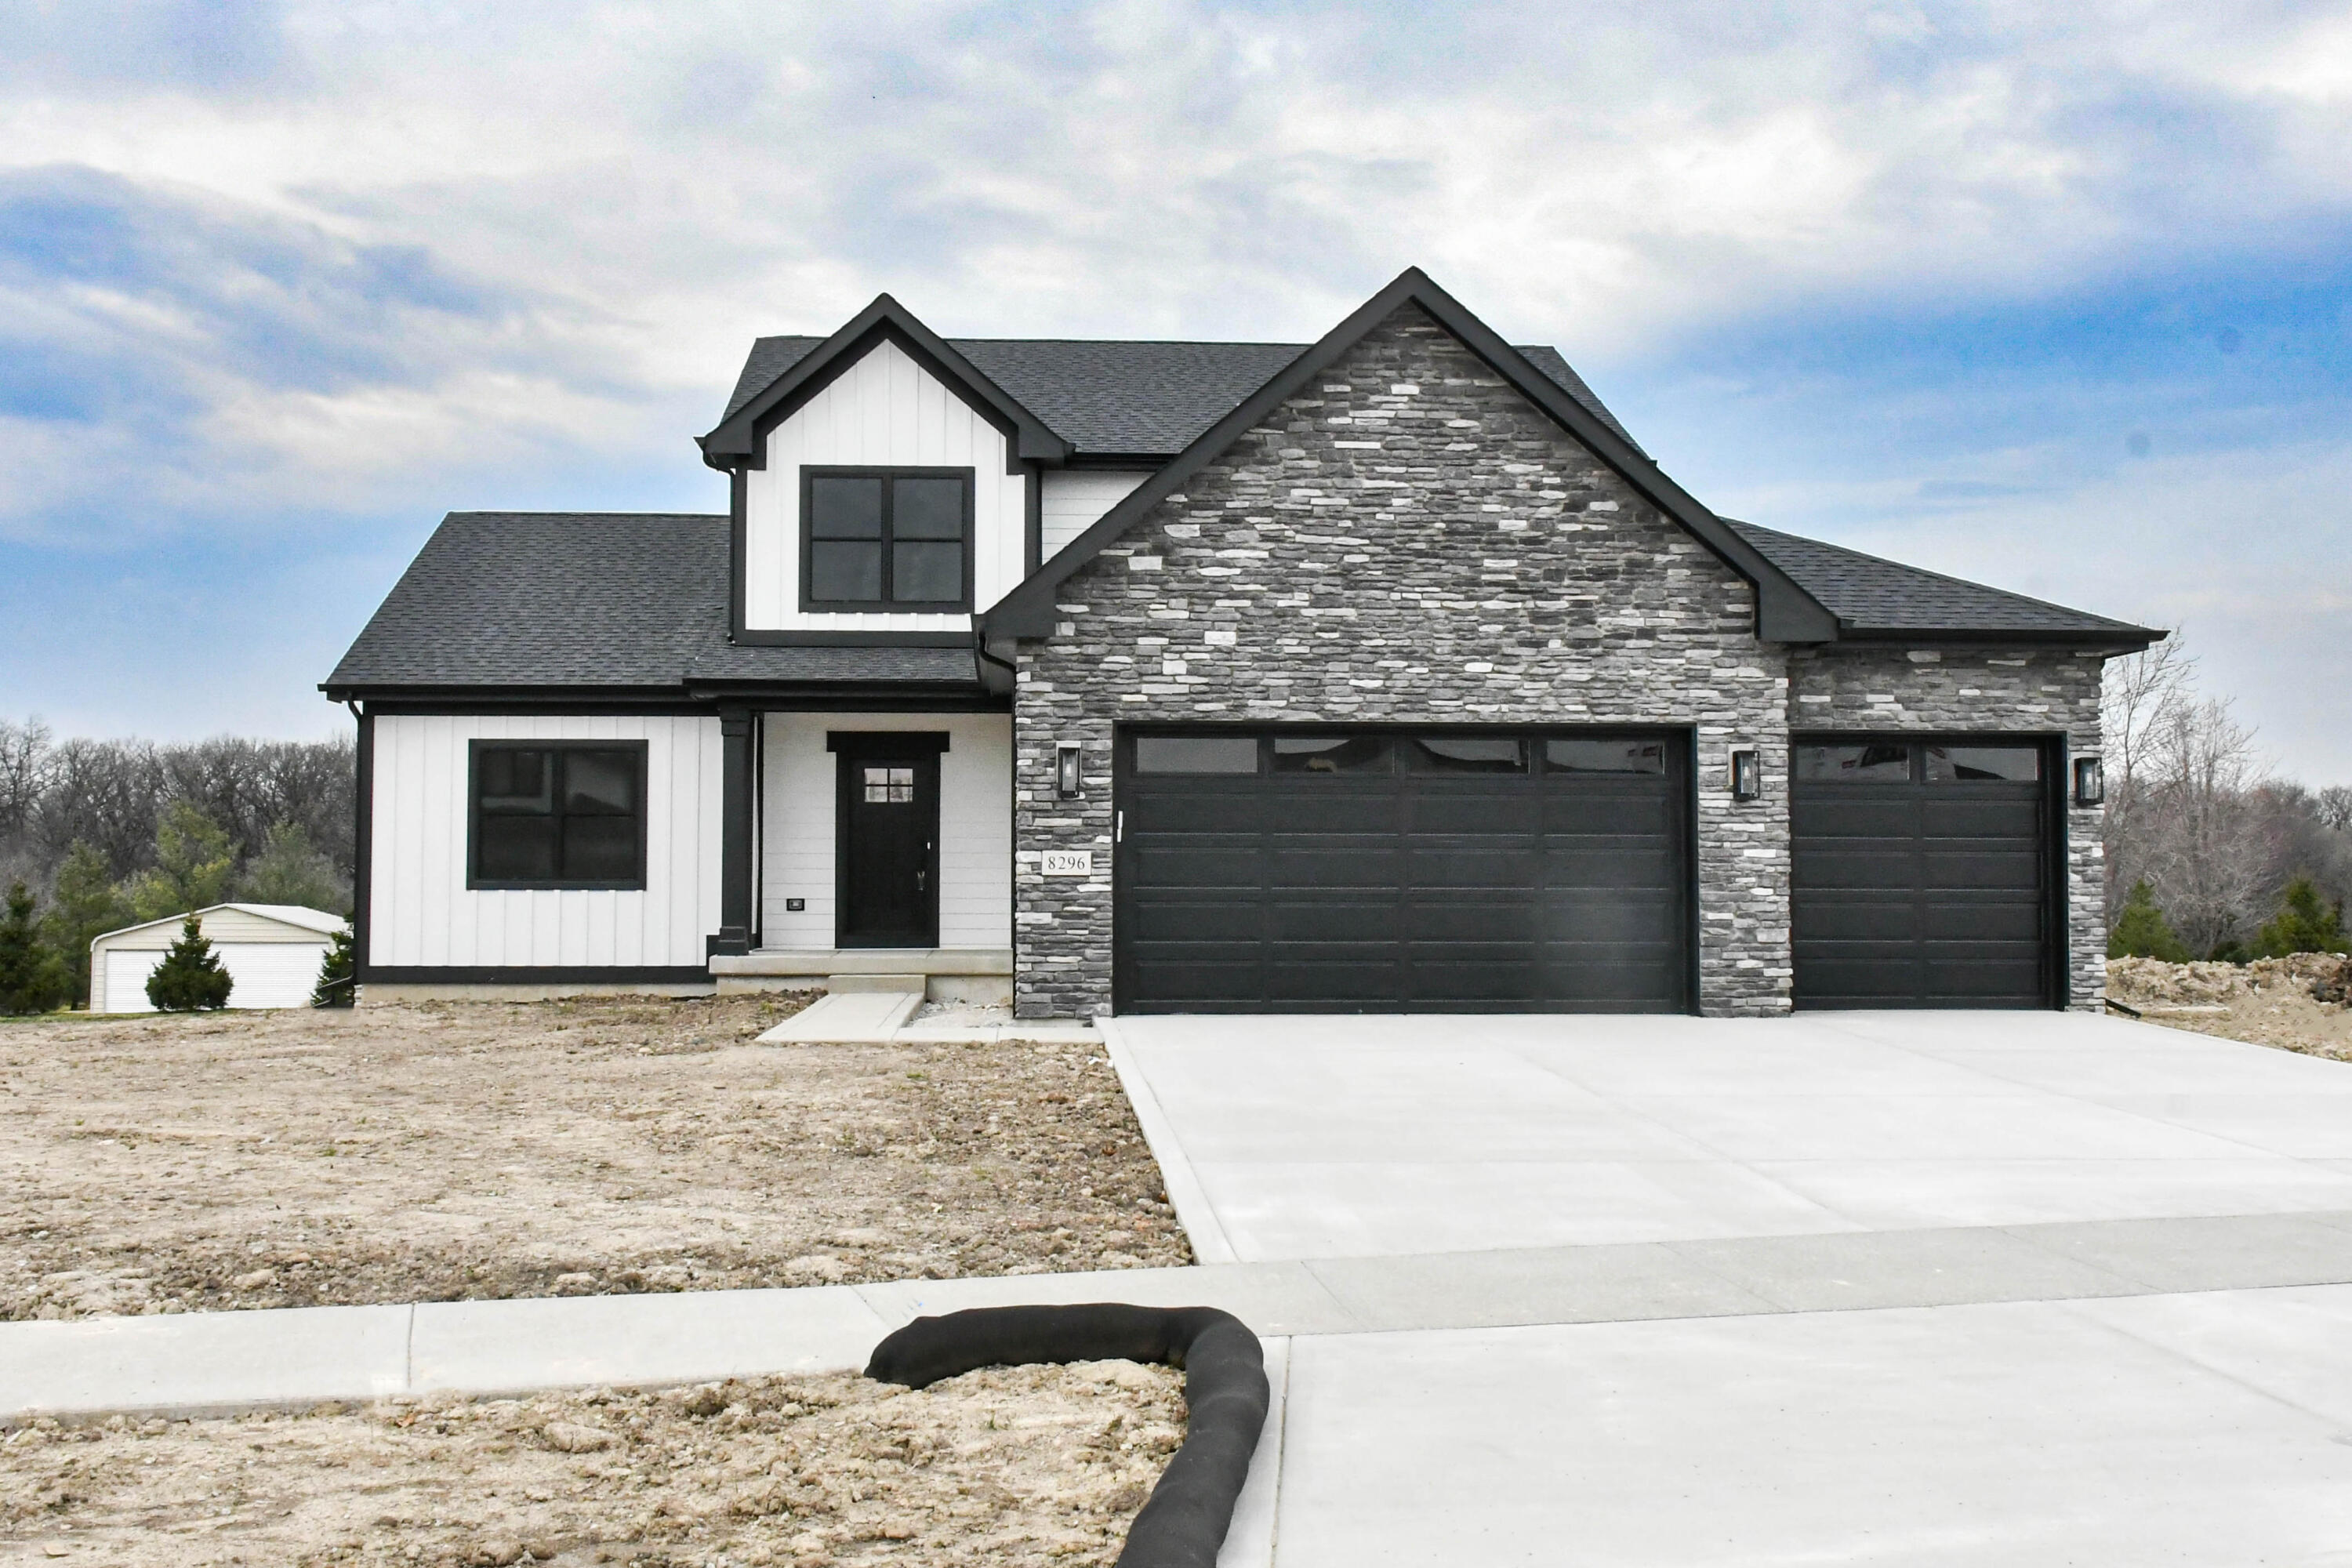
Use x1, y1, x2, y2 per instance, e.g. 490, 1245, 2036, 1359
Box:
981, 268, 1837, 642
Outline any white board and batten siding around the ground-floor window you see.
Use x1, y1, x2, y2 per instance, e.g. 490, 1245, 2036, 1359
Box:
367, 715, 722, 968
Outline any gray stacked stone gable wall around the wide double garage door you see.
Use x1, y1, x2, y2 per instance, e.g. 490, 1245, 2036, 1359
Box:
1014, 306, 1790, 1018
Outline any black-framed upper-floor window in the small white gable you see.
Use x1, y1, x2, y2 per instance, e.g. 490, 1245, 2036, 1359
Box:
800, 468, 974, 614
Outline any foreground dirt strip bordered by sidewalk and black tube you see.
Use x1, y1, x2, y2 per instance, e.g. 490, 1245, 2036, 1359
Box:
0, 1361, 1185, 1568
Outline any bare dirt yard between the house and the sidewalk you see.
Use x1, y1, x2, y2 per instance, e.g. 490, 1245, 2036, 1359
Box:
0, 996, 1190, 1319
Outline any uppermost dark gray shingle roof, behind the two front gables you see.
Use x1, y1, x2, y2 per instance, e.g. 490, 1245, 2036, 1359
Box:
720, 339, 1632, 459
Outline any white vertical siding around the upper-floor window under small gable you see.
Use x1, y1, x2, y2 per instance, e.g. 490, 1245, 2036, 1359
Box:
743, 341, 1028, 633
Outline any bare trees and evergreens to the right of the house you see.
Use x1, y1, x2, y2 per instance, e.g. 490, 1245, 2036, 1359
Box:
2103, 635, 2352, 961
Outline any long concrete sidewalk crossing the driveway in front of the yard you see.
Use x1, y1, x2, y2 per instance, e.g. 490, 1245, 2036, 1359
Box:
0, 1213, 2352, 1420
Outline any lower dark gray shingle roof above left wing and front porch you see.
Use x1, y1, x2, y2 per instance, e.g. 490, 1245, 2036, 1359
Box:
327, 513, 976, 691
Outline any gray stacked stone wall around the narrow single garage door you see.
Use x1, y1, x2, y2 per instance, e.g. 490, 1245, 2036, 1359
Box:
1788, 647, 2107, 1011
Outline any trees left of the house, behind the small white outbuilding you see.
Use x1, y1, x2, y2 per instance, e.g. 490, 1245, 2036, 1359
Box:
0, 720, 358, 1011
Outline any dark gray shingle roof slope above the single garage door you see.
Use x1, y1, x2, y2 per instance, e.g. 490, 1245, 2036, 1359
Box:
1724, 517, 2145, 642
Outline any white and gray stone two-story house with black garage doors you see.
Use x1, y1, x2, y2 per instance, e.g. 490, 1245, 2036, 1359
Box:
325, 270, 2157, 1018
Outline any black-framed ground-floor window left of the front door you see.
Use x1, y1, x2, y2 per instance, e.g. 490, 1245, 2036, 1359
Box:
466, 741, 644, 891
